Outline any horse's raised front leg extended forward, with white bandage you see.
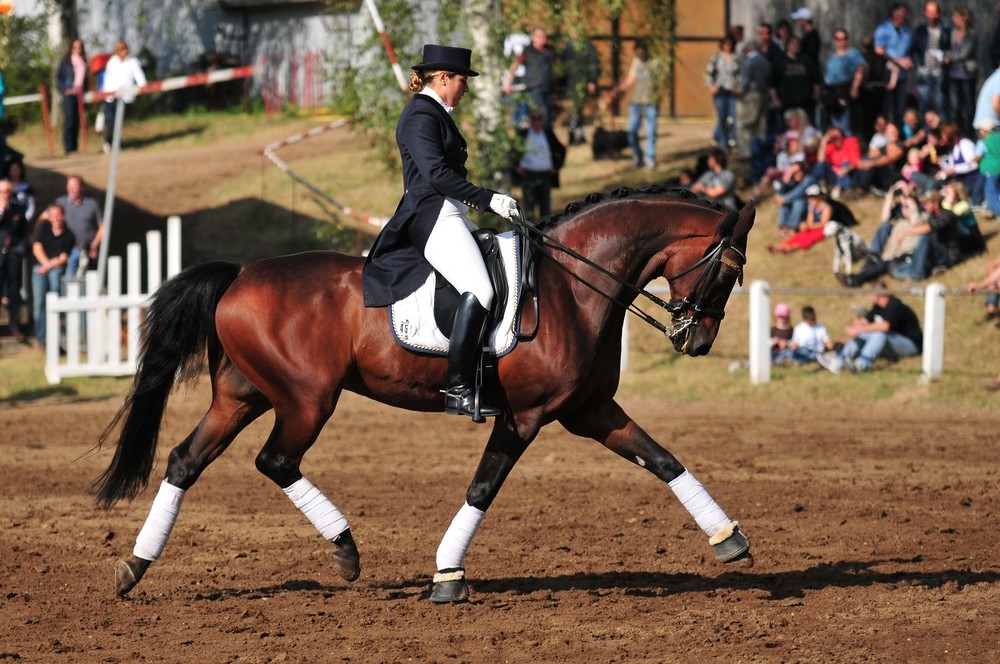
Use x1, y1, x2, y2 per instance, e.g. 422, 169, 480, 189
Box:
559, 399, 754, 567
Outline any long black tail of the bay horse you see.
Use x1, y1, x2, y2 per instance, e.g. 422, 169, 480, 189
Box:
90, 261, 241, 509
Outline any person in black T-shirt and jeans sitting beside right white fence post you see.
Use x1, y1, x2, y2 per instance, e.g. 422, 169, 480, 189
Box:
816, 282, 924, 373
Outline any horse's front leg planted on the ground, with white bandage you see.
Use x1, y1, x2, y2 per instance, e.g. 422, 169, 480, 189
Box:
430, 417, 537, 604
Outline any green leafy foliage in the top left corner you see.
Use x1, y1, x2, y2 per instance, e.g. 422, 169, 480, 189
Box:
0, 14, 53, 122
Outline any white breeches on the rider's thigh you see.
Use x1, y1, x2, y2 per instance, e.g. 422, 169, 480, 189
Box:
424, 198, 493, 309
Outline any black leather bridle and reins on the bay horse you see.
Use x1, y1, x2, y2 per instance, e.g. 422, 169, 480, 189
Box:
512, 208, 747, 348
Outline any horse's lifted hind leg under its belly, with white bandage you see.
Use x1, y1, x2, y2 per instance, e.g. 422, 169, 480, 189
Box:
256, 390, 361, 581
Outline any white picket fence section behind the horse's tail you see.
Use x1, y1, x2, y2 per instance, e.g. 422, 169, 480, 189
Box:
45, 217, 181, 385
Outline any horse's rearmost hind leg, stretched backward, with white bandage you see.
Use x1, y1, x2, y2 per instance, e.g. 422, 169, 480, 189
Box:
115, 366, 270, 597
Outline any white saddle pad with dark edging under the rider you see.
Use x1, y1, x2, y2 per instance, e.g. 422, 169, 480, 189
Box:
389, 231, 521, 357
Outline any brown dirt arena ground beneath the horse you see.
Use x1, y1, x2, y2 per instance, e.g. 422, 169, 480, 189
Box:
0, 378, 1000, 662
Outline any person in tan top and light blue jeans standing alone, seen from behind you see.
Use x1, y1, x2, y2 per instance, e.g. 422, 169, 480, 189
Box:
615, 42, 663, 168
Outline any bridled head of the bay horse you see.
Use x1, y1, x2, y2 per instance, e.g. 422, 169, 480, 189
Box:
667, 203, 756, 356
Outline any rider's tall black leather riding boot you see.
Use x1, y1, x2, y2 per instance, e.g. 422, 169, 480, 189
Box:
444, 293, 500, 422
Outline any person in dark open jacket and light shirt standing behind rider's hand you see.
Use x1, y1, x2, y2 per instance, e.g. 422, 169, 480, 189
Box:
515, 111, 566, 219
